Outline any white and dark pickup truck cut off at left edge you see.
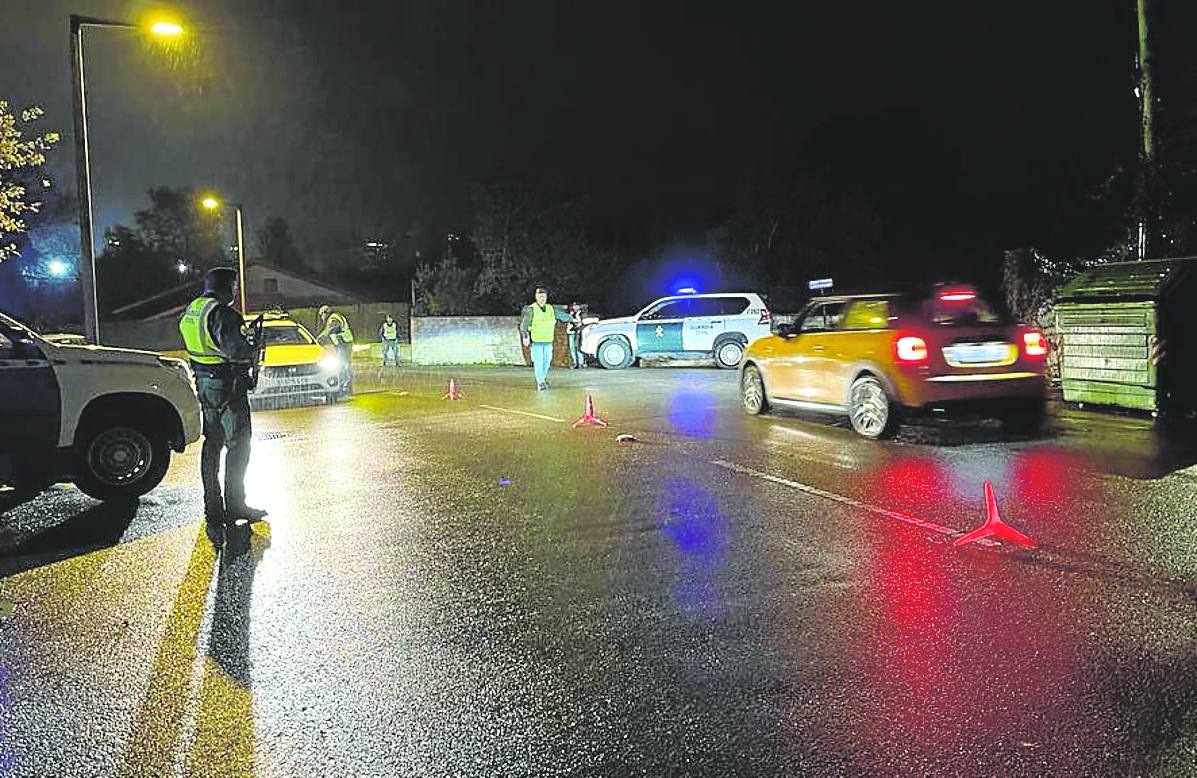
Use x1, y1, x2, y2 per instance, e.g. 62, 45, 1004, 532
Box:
0, 314, 201, 500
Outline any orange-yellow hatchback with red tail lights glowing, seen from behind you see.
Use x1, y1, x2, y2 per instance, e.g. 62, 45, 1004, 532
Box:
740, 286, 1047, 438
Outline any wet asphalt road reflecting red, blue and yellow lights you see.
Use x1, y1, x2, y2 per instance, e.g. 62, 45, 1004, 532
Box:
0, 369, 1197, 776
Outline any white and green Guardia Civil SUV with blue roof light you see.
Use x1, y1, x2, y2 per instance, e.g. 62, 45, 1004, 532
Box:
581, 292, 772, 370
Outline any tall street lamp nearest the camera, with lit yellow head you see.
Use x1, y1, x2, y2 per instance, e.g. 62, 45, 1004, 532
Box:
71, 13, 183, 344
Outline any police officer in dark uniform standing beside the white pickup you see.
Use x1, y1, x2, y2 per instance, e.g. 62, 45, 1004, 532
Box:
178, 267, 266, 546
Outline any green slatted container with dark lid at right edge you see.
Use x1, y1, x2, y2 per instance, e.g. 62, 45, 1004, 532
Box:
1056, 257, 1197, 412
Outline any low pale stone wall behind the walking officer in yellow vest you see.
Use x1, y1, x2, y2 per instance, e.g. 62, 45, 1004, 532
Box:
412, 316, 570, 367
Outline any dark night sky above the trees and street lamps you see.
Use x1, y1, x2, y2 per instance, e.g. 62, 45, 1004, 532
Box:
0, 0, 1197, 272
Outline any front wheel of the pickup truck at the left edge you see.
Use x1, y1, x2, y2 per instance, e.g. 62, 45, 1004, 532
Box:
75, 419, 170, 500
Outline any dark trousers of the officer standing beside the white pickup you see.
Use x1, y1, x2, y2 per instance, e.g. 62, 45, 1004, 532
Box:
193, 365, 254, 522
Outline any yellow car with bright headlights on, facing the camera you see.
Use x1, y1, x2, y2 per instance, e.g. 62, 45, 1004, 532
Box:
247, 312, 347, 409
